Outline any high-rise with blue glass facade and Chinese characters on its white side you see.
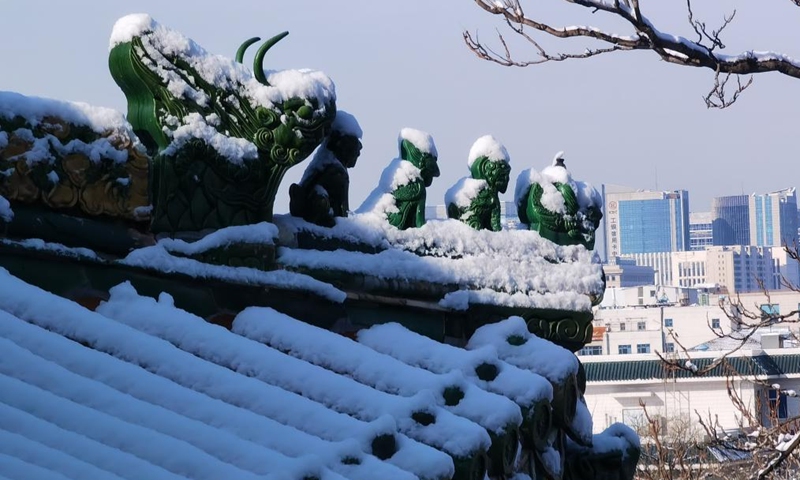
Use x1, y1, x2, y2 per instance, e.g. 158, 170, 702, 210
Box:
603, 185, 689, 258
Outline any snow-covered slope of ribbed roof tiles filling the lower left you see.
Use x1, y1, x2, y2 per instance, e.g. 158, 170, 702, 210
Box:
0, 269, 580, 480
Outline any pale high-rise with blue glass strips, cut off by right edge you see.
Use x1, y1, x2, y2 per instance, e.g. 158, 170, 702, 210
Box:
748, 188, 797, 247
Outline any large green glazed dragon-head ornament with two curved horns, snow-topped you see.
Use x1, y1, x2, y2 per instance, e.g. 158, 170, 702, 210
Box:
109, 15, 336, 233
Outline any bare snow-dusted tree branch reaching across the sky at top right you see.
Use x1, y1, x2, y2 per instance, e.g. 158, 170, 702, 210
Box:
463, 0, 800, 108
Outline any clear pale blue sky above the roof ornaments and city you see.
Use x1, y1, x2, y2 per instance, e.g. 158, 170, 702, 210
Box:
0, 0, 800, 213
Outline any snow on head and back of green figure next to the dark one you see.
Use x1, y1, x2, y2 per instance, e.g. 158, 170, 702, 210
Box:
356, 128, 439, 217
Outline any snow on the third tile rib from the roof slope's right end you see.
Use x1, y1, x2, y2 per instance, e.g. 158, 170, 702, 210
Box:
233, 307, 522, 434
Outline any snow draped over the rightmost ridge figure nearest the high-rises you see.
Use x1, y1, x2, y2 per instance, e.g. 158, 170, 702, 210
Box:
514, 152, 603, 214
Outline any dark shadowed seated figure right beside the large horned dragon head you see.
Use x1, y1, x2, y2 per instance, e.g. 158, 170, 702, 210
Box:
289, 110, 362, 227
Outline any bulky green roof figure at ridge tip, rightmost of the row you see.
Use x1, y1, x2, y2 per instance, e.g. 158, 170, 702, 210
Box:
514, 152, 603, 250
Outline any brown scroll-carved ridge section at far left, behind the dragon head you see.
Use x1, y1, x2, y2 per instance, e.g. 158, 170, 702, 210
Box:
0, 117, 149, 221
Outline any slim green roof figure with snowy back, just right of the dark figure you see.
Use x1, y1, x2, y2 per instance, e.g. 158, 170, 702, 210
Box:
357, 128, 439, 230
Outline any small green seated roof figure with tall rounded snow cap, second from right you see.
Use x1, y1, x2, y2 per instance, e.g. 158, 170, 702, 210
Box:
445, 135, 511, 232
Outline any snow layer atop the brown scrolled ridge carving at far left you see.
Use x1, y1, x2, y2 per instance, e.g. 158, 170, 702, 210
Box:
0, 91, 144, 167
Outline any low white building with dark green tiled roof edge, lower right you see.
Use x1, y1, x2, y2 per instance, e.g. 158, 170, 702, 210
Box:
581, 349, 800, 435
